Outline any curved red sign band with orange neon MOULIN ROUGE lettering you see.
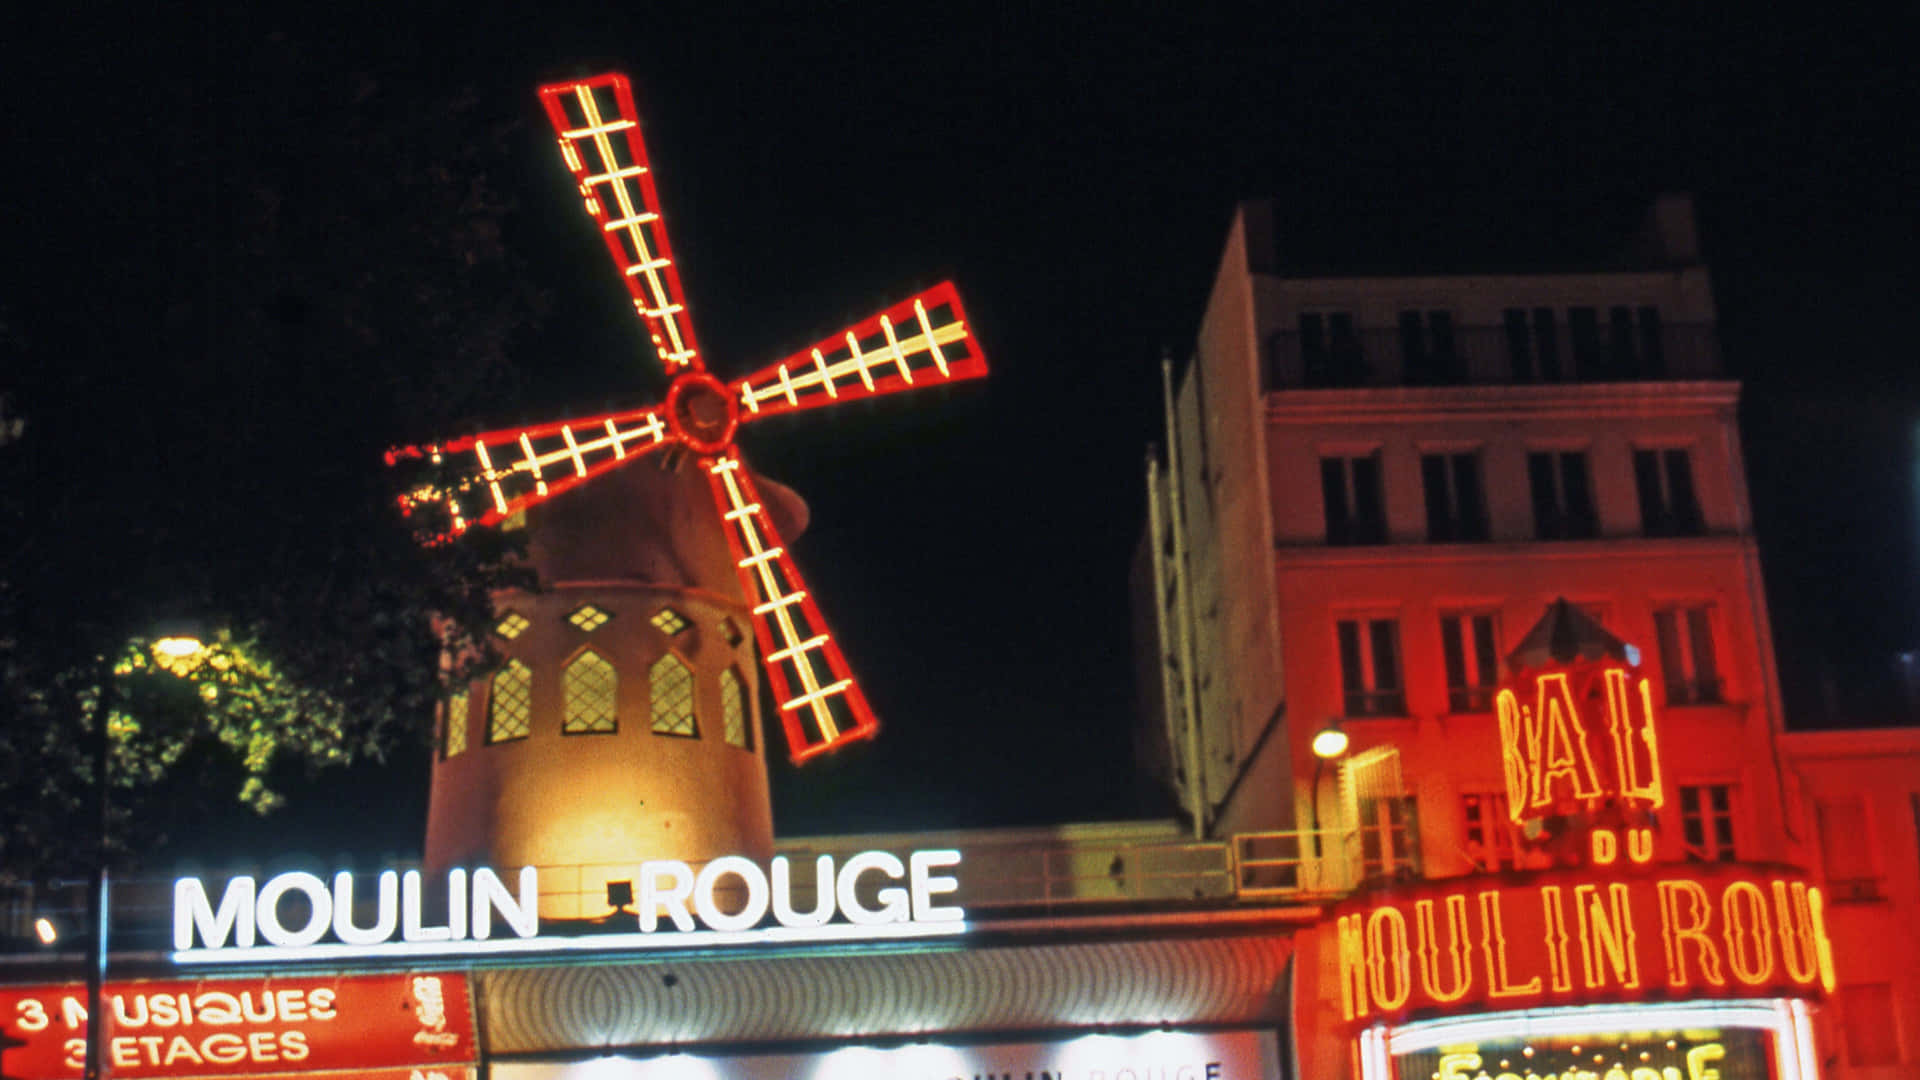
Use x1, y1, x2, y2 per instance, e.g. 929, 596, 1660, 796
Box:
1323, 863, 1834, 1024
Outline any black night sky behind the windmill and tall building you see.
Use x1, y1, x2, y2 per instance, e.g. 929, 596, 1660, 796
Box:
0, 4, 1920, 853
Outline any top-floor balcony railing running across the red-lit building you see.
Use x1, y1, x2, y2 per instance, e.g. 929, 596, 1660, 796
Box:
1261, 323, 1720, 390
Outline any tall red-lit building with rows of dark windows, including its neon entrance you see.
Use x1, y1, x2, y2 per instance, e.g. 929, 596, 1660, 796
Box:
1137, 196, 1920, 1080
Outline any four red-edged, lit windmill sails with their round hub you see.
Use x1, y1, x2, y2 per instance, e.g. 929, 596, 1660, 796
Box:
388, 73, 987, 763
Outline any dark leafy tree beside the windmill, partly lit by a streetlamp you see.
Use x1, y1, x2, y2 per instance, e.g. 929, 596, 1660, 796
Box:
0, 35, 543, 876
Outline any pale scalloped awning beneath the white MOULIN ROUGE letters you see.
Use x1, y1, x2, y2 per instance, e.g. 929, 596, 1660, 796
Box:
472, 928, 1292, 1059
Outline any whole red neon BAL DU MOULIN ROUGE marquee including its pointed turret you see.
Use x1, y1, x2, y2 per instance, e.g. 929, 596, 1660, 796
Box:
1302, 601, 1837, 1080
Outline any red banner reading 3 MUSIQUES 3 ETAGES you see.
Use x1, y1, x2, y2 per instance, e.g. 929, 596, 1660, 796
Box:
0, 972, 476, 1080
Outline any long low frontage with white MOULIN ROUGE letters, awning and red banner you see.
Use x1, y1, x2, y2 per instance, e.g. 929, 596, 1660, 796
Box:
0, 832, 1311, 1080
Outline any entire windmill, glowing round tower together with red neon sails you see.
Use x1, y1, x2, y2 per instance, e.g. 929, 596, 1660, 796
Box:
388, 75, 987, 917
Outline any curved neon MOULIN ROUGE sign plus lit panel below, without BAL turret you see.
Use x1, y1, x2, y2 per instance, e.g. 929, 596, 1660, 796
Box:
1319, 865, 1834, 1080
